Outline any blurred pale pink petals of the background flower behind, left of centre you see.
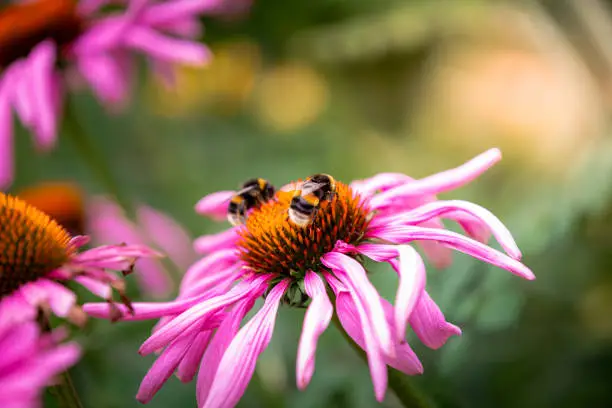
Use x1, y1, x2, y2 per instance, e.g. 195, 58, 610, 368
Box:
87, 198, 196, 298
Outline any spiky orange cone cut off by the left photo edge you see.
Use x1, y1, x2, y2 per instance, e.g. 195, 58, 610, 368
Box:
0, 193, 75, 298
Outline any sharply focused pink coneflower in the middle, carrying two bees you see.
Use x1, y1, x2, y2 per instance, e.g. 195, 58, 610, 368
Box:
84, 149, 534, 408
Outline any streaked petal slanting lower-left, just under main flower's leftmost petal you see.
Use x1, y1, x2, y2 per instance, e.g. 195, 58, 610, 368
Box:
139, 275, 272, 355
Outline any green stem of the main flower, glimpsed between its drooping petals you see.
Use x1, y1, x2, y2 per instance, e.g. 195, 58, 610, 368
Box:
332, 312, 434, 408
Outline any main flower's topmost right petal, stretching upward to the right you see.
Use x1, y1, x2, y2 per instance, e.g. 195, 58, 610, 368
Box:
370, 148, 501, 208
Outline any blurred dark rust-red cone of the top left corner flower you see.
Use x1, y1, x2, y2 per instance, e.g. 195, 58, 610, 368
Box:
0, 0, 82, 67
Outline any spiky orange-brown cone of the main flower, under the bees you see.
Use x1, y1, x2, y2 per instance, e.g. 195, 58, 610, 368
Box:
238, 182, 369, 276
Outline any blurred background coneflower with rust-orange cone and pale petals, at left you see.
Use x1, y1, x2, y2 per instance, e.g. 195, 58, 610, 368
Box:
18, 181, 196, 298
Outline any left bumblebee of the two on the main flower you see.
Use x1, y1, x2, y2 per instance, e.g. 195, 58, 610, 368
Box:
227, 178, 276, 225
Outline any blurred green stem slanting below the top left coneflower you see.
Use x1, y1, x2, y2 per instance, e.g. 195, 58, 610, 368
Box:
64, 101, 134, 217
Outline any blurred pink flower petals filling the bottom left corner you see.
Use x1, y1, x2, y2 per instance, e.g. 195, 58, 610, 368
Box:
0, 301, 80, 408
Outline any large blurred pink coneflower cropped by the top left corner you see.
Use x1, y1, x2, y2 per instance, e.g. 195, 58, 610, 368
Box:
0, 0, 217, 188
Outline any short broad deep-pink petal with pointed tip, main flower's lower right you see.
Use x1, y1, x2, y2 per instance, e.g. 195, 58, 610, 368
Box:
410, 291, 461, 349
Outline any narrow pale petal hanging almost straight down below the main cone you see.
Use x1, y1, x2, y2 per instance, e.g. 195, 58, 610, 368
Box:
296, 271, 333, 390
